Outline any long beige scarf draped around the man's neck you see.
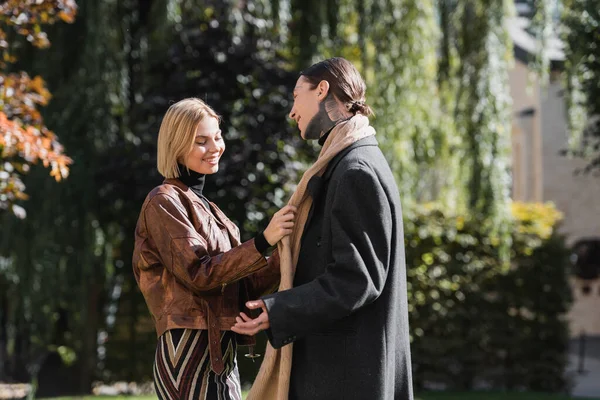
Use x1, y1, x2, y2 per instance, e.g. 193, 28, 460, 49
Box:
247, 114, 375, 400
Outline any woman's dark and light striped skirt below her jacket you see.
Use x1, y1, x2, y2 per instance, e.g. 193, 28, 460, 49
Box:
154, 329, 242, 400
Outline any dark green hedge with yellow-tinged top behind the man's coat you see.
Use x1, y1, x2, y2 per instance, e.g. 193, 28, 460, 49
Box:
406, 204, 571, 391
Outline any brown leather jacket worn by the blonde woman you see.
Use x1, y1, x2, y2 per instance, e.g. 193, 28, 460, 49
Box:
133, 179, 279, 373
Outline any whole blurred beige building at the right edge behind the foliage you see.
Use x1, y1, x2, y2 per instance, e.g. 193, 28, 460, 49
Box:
509, 0, 600, 336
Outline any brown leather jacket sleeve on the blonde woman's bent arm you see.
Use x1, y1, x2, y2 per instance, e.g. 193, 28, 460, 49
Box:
142, 194, 266, 293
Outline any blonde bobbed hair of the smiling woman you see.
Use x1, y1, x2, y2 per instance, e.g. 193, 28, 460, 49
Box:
156, 98, 220, 178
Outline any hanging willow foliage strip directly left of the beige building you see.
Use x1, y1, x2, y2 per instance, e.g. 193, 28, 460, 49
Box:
441, 0, 512, 260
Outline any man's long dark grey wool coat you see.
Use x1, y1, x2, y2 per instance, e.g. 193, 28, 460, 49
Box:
263, 137, 413, 400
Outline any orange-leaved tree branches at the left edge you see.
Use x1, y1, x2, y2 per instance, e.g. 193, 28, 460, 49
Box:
0, 0, 77, 218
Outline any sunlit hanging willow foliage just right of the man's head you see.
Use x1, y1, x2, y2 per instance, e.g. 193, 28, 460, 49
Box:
361, 0, 446, 204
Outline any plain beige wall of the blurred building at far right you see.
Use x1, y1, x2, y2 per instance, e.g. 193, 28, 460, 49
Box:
510, 60, 600, 336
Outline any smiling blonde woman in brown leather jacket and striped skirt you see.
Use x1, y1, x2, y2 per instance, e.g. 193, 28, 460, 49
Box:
133, 99, 295, 400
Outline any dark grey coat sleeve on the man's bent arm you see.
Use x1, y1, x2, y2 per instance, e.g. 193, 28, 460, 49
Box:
263, 167, 394, 348
